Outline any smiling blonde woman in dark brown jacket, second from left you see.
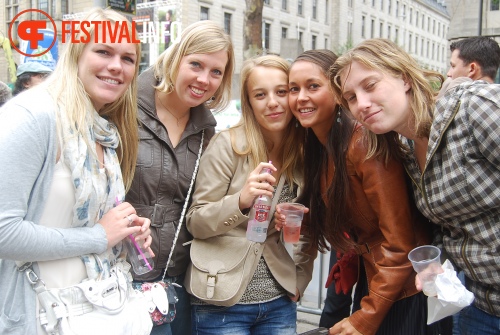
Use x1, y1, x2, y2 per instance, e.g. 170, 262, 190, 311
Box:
127, 21, 234, 335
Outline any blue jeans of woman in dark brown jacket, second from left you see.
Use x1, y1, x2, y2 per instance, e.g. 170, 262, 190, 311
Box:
134, 274, 191, 335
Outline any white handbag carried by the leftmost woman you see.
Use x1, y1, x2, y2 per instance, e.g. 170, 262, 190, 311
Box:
18, 255, 152, 335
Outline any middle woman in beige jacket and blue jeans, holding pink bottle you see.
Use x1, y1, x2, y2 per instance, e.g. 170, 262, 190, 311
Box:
186, 56, 316, 335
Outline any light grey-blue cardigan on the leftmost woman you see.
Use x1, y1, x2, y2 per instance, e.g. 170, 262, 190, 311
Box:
0, 88, 107, 334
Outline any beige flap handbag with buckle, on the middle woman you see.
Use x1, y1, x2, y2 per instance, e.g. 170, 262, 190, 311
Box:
185, 176, 284, 306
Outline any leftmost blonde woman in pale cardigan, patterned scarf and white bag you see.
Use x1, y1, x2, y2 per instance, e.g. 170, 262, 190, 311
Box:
0, 8, 151, 334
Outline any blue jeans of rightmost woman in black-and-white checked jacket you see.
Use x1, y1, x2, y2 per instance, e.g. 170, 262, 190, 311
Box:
459, 305, 500, 335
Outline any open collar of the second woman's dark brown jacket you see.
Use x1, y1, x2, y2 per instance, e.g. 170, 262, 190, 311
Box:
137, 66, 217, 133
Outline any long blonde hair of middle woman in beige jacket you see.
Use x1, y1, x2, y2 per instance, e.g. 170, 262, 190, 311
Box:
229, 55, 305, 186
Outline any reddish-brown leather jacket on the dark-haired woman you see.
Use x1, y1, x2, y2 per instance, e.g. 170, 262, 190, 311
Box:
347, 127, 430, 335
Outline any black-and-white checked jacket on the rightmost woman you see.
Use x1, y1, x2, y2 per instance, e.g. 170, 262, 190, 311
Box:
406, 81, 500, 316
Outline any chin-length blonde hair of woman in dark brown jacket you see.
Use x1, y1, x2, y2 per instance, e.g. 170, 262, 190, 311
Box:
154, 20, 234, 111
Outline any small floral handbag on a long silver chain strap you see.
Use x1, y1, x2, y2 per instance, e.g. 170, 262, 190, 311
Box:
132, 130, 205, 326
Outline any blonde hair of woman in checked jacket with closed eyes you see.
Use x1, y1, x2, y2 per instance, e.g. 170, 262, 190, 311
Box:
330, 38, 444, 158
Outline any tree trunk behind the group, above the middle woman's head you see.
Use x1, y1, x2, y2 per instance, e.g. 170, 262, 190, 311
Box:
243, 0, 264, 59
